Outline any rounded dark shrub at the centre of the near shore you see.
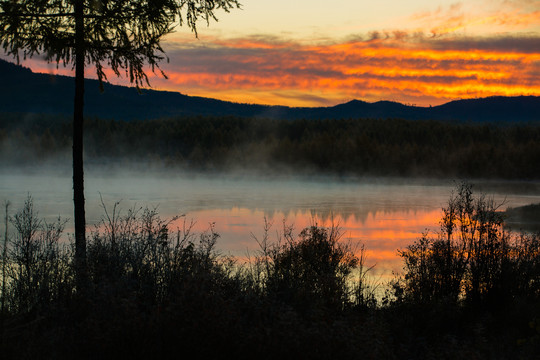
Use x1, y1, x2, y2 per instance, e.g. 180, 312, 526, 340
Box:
253, 221, 367, 313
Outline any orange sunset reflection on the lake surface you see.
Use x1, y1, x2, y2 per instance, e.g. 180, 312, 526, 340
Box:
167, 207, 441, 275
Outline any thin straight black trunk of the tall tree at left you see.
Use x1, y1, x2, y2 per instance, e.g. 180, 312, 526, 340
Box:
73, 0, 86, 291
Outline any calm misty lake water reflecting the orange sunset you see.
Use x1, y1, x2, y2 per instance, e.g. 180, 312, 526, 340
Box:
0, 170, 540, 277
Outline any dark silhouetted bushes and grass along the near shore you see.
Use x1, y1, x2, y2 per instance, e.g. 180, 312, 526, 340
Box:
0, 184, 540, 359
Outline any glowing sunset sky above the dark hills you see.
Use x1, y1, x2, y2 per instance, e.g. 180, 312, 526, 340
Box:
4, 0, 540, 106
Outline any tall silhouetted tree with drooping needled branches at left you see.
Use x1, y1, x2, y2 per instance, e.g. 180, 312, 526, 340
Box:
0, 0, 240, 292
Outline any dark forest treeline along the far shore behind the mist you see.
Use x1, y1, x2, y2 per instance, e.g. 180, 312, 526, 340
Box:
0, 114, 540, 179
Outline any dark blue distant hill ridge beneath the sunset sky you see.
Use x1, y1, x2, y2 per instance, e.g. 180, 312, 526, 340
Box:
0, 60, 540, 123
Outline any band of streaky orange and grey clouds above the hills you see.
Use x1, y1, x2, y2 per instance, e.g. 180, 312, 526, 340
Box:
146, 33, 540, 106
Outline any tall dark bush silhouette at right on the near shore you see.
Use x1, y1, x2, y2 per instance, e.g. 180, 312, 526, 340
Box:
393, 183, 540, 306
